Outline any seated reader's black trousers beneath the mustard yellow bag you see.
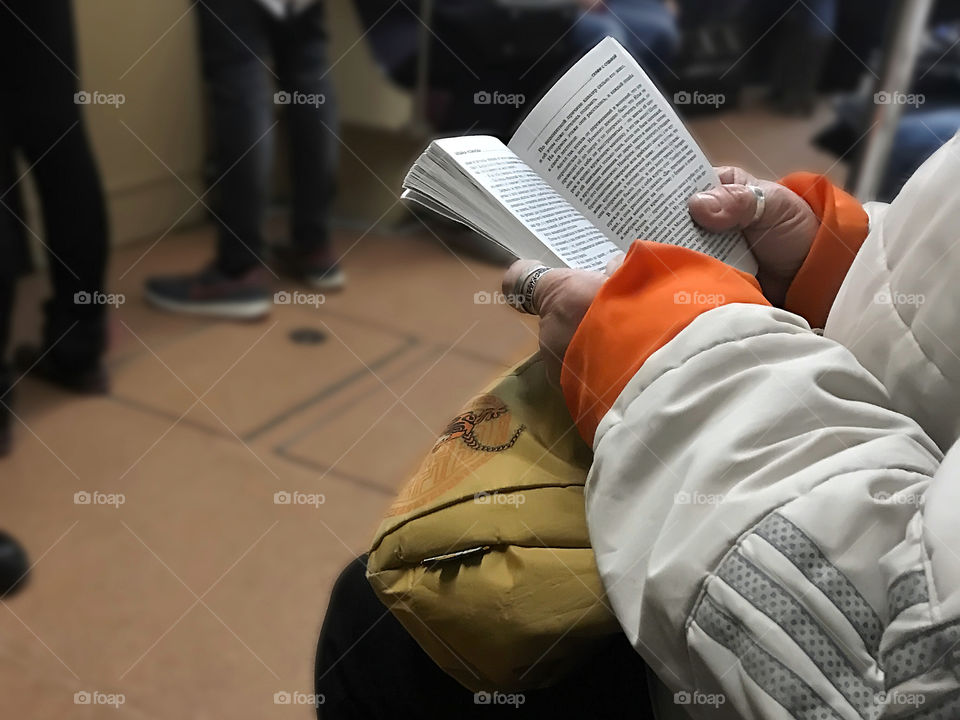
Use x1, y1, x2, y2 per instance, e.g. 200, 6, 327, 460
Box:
315, 556, 653, 720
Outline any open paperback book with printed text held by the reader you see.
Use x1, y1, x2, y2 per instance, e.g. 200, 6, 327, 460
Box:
402, 37, 757, 273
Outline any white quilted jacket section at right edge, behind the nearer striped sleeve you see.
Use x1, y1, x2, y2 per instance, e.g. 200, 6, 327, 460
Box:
824, 135, 960, 450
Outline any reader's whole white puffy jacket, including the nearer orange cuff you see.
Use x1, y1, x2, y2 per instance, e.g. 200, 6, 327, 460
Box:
563, 139, 960, 720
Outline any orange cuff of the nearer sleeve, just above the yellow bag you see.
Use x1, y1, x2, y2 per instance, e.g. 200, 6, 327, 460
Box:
560, 241, 769, 445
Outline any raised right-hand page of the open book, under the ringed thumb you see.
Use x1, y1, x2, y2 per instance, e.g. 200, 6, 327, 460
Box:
510, 38, 757, 273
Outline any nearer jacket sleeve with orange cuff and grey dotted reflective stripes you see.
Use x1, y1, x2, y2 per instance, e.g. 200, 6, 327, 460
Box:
562, 244, 940, 720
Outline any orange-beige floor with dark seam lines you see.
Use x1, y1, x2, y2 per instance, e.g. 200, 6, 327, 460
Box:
0, 104, 839, 720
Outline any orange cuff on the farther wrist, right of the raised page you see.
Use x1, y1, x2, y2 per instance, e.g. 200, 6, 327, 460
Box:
780, 173, 869, 327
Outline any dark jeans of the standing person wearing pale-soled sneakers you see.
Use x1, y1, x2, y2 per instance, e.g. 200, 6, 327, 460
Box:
200, 0, 339, 274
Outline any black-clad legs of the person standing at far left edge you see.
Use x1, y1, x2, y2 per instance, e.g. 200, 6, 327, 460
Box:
0, 0, 107, 384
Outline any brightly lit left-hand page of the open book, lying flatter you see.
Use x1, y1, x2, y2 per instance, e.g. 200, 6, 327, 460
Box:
426, 135, 618, 270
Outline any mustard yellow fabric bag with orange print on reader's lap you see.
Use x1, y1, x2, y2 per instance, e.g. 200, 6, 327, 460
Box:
367, 355, 620, 691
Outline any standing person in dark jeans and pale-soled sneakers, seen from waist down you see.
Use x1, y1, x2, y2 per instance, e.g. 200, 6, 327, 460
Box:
146, 0, 344, 319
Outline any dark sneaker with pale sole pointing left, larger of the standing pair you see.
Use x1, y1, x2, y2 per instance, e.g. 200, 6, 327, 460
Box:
145, 266, 271, 320
